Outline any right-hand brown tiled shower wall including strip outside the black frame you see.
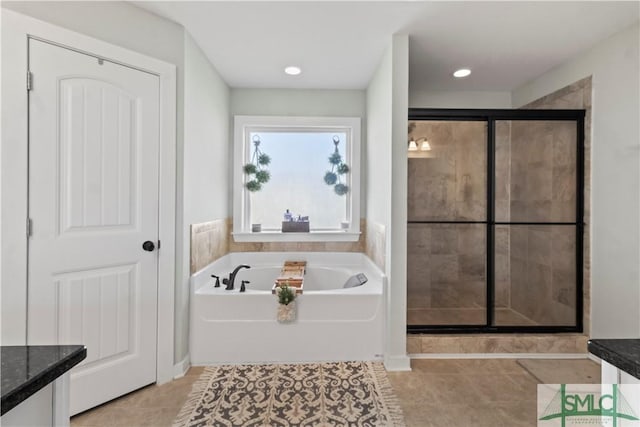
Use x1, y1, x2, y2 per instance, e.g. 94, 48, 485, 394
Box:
510, 77, 592, 334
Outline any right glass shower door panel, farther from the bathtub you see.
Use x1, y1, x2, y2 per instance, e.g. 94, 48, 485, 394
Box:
493, 120, 581, 326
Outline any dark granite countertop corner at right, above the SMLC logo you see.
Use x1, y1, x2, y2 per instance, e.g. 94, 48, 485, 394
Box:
588, 339, 640, 379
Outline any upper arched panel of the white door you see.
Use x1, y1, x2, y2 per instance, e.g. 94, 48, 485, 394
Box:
60, 78, 138, 232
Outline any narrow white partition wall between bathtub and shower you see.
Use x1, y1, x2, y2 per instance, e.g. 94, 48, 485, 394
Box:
366, 35, 409, 370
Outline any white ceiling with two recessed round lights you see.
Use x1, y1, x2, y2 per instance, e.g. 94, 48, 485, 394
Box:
134, 1, 640, 91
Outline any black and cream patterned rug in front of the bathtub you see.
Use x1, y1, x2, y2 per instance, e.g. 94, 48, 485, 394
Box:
173, 362, 405, 427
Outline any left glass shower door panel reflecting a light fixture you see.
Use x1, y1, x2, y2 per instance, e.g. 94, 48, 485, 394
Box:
407, 121, 487, 325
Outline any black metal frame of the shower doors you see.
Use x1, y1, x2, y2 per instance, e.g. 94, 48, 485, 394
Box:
407, 108, 585, 334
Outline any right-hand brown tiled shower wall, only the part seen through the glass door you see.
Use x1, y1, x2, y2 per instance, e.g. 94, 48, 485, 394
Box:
504, 121, 576, 325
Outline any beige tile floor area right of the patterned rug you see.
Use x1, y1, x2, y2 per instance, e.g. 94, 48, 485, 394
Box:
388, 359, 600, 427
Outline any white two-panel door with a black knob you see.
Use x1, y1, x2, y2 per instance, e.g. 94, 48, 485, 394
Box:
27, 39, 159, 414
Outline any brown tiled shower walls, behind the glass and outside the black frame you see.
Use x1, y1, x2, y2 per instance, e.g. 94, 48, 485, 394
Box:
407, 78, 591, 332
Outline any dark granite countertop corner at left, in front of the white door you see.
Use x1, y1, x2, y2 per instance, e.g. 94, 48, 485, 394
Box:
0, 345, 87, 415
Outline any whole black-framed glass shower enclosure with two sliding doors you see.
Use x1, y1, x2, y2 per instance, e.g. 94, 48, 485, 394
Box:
407, 109, 585, 333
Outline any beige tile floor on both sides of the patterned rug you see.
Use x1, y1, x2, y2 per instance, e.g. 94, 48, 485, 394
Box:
71, 359, 600, 427
